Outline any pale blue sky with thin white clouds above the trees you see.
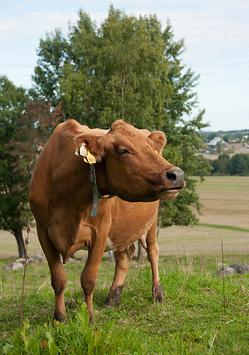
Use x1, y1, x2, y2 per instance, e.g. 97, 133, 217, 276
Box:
0, 0, 249, 131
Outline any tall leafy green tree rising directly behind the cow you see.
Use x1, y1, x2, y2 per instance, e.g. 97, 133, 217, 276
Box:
31, 6, 208, 225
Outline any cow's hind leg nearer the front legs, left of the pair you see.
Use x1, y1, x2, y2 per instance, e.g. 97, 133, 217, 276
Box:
106, 244, 135, 306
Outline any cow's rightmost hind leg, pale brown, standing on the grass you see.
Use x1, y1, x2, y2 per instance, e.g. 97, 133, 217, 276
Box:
146, 219, 164, 302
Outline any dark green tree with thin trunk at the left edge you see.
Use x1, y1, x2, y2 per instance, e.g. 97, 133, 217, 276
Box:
0, 76, 30, 257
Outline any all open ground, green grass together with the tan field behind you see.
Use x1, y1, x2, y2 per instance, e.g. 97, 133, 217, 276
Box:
0, 177, 249, 354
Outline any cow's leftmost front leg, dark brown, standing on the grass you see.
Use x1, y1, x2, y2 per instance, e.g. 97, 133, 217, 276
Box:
37, 223, 67, 322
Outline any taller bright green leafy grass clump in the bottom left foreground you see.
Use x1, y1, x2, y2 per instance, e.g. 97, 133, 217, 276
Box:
2, 305, 144, 355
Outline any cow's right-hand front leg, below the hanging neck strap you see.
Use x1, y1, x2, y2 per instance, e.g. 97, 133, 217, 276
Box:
81, 233, 107, 322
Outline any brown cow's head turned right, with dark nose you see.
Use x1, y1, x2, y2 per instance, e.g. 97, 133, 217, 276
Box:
75, 120, 185, 201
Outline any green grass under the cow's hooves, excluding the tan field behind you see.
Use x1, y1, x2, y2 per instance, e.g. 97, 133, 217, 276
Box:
0, 256, 249, 354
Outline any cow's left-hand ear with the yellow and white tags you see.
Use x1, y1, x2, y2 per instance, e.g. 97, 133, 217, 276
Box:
74, 134, 104, 164
